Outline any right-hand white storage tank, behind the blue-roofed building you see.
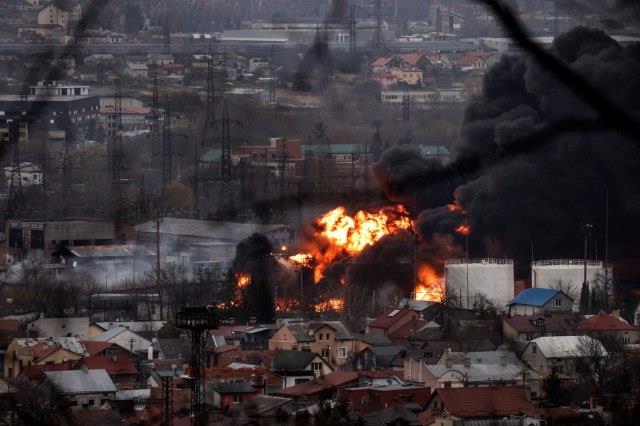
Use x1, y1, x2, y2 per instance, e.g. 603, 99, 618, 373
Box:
531, 259, 613, 302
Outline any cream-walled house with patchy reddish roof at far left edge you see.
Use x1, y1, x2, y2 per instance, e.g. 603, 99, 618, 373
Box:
4, 337, 86, 378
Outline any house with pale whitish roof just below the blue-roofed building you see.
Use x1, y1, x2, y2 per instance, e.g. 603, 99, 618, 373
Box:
520, 336, 607, 377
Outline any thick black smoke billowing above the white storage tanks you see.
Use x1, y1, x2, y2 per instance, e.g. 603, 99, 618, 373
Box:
376, 28, 640, 278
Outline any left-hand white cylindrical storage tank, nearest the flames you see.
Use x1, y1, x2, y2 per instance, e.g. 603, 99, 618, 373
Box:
445, 259, 514, 308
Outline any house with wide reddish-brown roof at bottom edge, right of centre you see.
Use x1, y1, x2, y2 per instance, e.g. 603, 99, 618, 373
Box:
420, 386, 540, 425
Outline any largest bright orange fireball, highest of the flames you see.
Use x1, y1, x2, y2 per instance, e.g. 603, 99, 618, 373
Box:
293, 205, 412, 282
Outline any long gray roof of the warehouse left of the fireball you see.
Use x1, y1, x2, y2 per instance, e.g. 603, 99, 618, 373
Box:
135, 217, 288, 242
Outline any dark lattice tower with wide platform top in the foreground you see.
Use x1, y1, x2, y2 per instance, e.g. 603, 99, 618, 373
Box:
176, 306, 218, 425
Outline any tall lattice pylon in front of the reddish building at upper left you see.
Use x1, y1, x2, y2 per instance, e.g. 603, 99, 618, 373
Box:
107, 89, 124, 212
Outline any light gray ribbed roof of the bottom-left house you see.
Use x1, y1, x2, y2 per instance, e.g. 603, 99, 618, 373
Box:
44, 369, 116, 394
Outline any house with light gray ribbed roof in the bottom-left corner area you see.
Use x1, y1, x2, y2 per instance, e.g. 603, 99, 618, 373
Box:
44, 369, 117, 409
